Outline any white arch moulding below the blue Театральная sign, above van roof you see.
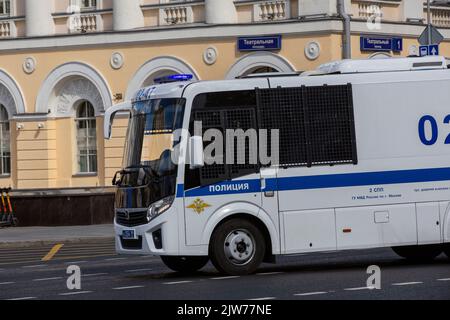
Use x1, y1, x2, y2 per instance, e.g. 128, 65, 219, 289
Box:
225, 51, 296, 80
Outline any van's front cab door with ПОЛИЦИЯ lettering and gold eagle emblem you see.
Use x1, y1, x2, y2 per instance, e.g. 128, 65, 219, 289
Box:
184, 90, 261, 246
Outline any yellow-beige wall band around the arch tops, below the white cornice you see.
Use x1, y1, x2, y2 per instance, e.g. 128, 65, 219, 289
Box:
0, 36, 342, 112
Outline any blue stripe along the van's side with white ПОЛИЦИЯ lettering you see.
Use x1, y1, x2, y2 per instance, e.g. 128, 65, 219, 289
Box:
177, 168, 450, 197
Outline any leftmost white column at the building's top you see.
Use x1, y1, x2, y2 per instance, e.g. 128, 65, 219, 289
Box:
25, 0, 55, 37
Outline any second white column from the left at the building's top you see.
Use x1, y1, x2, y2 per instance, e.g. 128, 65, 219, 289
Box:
113, 0, 144, 31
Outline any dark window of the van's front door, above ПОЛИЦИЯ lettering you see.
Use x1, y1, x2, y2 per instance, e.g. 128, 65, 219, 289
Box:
185, 90, 259, 190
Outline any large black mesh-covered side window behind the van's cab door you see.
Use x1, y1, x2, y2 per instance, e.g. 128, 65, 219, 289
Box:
256, 84, 358, 167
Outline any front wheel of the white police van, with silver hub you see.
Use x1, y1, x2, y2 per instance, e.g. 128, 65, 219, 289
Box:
209, 219, 266, 276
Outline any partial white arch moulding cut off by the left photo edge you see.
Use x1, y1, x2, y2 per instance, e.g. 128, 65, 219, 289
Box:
0, 69, 26, 118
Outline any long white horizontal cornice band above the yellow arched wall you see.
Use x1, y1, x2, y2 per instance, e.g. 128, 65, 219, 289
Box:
0, 20, 344, 52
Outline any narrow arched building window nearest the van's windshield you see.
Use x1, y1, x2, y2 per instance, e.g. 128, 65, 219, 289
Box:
75, 101, 97, 173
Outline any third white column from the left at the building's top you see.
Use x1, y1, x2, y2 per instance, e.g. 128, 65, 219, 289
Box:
205, 0, 237, 24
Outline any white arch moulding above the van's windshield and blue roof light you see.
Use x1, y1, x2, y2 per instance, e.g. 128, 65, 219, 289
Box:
125, 56, 200, 100
